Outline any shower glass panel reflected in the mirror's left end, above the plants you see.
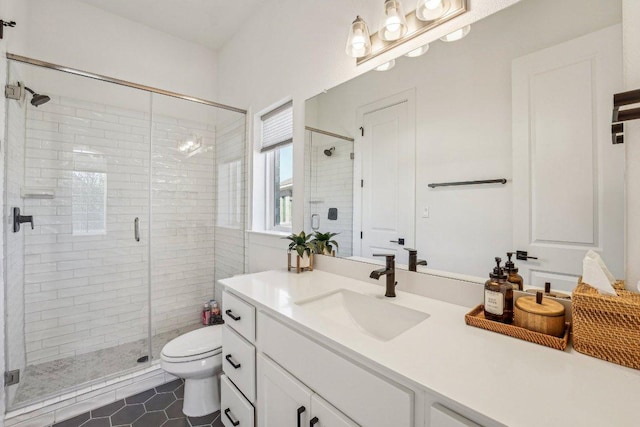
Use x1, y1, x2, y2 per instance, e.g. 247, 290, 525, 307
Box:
304, 130, 353, 257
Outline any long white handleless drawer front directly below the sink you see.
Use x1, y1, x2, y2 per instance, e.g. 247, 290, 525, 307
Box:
258, 312, 414, 427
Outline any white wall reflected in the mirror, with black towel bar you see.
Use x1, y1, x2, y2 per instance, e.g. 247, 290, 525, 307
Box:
305, 0, 623, 277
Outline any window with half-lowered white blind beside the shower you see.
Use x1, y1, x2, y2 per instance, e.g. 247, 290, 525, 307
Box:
260, 102, 293, 231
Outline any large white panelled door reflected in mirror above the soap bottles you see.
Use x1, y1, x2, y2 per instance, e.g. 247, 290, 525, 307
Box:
512, 25, 624, 291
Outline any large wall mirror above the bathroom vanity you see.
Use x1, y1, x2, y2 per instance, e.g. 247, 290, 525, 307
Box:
304, 0, 624, 290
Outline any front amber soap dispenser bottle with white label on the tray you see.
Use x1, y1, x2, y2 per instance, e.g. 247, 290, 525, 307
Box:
484, 257, 513, 323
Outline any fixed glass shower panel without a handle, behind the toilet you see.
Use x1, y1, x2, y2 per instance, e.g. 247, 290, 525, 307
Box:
151, 94, 245, 352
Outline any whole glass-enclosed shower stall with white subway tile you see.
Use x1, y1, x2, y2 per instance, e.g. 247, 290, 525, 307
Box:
4, 55, 247, 410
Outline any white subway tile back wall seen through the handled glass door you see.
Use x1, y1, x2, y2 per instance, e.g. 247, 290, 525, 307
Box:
21, 96, 150, 364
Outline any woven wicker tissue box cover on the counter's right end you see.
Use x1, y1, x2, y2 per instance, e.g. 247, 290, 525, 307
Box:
571, 281, 640, 369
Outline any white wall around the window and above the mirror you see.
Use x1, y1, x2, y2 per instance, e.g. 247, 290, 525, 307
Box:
218, 0, 518, 271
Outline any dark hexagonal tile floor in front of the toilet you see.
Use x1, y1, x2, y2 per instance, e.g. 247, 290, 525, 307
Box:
52, 380, 223, 427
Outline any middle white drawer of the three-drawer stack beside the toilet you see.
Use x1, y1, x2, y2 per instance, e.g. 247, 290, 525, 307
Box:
222, 324, 256, 403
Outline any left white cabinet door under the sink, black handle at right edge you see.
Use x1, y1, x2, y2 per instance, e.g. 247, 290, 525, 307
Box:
257, 354, 312, 427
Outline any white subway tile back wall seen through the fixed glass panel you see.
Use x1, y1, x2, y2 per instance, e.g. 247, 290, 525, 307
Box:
151, 113, 216, 335
